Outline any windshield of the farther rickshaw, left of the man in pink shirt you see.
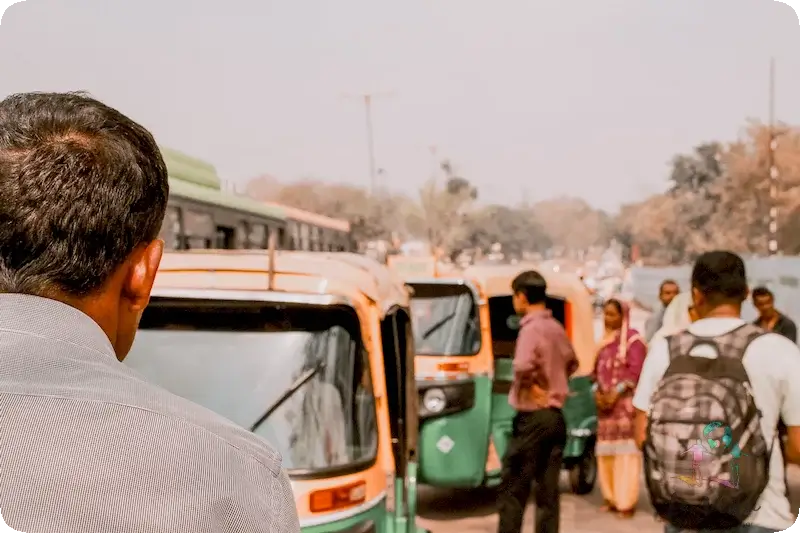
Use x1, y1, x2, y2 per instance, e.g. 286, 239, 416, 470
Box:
411, 283, 481, 355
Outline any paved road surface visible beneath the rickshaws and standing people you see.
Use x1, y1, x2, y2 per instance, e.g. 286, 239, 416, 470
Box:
418, 466, 800, 533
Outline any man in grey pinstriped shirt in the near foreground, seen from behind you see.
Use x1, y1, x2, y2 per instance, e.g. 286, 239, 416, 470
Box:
0, 93, 299, 533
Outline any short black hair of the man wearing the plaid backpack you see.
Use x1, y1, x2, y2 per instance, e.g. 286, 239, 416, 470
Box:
692, 251, 747, 305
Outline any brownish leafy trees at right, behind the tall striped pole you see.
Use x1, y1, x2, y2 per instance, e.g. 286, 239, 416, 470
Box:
614, 122, 800, 263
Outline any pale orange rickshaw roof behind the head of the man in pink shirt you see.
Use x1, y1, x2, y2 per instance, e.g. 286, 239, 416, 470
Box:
464, 264, 588, 300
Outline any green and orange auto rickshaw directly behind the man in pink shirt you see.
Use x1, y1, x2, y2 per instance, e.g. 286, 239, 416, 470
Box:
396, 265, 597, 494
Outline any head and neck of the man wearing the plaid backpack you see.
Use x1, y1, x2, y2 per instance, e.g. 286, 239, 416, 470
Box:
692, 251, 748, 318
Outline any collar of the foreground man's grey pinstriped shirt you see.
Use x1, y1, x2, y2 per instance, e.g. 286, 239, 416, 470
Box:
0, 294, 116, 359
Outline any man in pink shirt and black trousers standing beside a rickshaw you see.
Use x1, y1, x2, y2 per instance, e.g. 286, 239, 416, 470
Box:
497, 270, 578, 533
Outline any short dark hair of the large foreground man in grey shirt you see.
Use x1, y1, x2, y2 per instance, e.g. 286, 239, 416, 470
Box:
0, 93, 169, 296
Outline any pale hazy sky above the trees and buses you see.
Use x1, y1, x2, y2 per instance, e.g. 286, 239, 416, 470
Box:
0, 0, 800, 209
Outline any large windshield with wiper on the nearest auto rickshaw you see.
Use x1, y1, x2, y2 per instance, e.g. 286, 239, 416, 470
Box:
125, 300, 377, 476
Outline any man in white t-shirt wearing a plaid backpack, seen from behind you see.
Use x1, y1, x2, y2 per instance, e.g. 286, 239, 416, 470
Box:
633, 251, 800, 533
